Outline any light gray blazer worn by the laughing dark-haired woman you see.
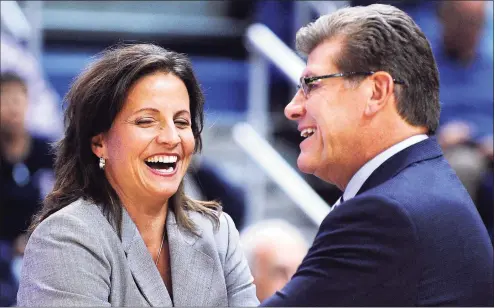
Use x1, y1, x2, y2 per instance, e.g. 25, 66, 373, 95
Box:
17, 200, 259, 306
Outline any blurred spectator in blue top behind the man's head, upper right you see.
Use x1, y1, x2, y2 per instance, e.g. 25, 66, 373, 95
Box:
432, 1, 493, 178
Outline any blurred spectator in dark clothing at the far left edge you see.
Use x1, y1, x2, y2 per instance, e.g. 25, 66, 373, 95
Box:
0, 72, 53, 303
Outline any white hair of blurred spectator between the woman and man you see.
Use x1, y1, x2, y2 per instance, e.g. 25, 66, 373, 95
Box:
240, 219, 308, 270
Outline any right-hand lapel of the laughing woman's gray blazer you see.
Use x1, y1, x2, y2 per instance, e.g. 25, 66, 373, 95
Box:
167, 211, 214, 307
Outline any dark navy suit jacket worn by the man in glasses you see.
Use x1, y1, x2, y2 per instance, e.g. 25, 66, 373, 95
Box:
263, 138, 494, 307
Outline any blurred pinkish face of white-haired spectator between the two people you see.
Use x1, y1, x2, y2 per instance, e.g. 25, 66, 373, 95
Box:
253, 242, 306, 302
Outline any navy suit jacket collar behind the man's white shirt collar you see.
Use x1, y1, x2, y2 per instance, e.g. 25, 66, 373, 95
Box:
357, 137, 443, 195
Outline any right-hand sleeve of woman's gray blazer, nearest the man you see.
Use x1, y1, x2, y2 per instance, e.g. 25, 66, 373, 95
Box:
221, 213, 259, 307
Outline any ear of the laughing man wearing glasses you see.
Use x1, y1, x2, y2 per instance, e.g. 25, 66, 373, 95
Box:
364, 72, 394, 116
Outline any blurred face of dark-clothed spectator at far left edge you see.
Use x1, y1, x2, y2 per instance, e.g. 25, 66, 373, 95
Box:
0, 82, 28, 134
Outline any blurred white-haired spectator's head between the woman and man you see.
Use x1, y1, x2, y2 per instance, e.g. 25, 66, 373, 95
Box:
241, 219, 308, 302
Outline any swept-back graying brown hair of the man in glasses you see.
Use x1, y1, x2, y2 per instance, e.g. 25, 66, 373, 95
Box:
296, 4, 440, 134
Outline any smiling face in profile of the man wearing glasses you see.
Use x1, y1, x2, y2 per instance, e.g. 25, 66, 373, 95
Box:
285, 39, 367, 187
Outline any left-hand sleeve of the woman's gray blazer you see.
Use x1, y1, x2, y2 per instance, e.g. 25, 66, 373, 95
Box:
17, 213, 111, 306
